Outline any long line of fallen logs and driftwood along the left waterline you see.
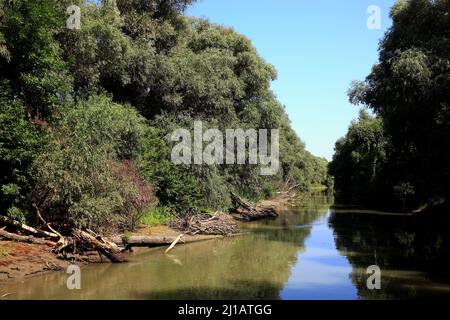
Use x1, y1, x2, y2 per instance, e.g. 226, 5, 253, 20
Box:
0, 193, 278, 262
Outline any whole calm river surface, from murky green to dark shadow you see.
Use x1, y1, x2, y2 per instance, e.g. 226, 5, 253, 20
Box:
0, 193, 450, 300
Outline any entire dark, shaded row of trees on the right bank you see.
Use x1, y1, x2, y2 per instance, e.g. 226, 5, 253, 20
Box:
329, 0, 450, 210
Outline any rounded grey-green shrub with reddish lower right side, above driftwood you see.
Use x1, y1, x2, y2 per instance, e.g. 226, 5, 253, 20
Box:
35, 97, 154, 231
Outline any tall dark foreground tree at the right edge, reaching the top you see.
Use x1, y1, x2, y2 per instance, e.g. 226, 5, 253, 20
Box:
335, 0, 450, 207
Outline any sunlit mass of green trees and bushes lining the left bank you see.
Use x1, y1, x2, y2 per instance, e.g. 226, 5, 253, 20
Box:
0, 0, 331, 229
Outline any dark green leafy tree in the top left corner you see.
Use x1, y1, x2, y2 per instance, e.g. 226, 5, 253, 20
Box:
0, 0, 72, 119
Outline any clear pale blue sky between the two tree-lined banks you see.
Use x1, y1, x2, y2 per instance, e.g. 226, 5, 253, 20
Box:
186, 0, 395, 160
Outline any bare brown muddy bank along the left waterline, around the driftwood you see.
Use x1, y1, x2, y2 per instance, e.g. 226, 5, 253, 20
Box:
0, 197, 290, 282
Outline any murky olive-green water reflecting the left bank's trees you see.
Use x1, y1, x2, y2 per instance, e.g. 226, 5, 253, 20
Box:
0, 192, 328, 299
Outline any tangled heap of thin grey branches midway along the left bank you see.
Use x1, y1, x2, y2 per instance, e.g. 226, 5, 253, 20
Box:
170, 212, 237, 236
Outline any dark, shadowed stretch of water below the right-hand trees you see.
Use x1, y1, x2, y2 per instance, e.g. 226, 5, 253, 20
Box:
329, 209, 450, 299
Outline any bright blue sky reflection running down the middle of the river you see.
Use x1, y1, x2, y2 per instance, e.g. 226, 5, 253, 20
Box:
280, 194, 357, 300
